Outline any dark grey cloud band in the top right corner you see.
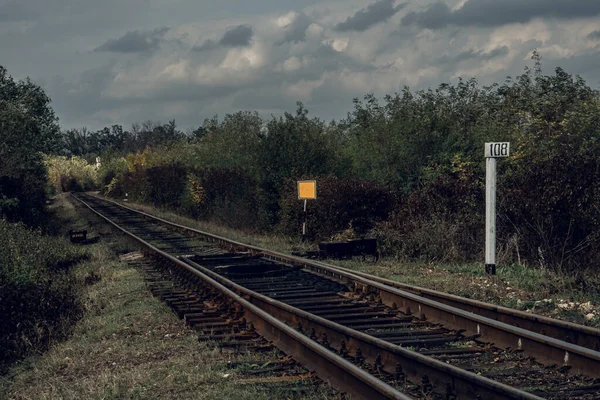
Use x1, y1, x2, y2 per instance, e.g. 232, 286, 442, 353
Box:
402, 0, 600, 29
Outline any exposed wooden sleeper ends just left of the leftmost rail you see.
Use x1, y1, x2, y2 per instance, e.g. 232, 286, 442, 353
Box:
129, 255, 334, 398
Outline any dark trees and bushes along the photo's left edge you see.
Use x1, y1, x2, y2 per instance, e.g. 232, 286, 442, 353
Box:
0, 67, 95, 374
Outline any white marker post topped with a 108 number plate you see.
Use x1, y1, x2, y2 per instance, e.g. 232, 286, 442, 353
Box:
485, 142, 510, 275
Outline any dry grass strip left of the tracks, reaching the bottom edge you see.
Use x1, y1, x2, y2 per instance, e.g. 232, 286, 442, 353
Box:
0, 195, 336, 400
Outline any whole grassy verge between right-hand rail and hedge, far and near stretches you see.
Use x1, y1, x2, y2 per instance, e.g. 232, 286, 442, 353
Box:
99, 193, 600, 327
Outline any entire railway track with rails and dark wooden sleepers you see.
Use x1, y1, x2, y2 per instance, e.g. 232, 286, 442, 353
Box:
72, 196, 600, 399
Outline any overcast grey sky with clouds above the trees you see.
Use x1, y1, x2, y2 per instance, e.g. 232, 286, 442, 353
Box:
0, 0, 600, 129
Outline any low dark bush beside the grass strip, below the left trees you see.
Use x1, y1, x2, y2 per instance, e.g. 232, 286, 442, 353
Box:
0, 195, 137, 374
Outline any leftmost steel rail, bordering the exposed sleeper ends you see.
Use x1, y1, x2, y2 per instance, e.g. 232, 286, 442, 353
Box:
73, 195, 411, 400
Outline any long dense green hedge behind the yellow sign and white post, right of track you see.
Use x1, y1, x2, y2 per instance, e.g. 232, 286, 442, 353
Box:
55, 53, 600, 273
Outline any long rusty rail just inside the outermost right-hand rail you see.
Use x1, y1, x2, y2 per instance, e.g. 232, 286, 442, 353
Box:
81, 196, 600, 378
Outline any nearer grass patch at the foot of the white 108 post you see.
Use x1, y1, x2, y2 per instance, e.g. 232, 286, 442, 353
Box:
330, 259, 600, 327
